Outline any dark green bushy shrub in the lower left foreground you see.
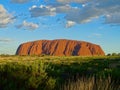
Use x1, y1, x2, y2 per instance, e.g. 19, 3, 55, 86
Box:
0, 62, 55, 90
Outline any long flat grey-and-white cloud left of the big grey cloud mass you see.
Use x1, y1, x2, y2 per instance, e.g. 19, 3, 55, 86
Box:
29, 4, 78, 17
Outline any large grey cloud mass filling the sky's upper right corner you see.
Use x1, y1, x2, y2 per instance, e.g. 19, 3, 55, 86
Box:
66, 0, 120, 24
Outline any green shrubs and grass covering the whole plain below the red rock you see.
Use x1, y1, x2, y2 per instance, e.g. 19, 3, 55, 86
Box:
0, 55, 120, 90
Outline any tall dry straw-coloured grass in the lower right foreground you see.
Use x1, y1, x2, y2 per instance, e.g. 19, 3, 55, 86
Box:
60, 76, 120, 90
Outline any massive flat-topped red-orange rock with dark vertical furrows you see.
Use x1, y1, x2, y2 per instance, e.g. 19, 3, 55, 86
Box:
16, 39, 105, 56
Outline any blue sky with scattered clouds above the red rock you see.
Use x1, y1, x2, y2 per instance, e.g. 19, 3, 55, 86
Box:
0, 0, 120, 54
